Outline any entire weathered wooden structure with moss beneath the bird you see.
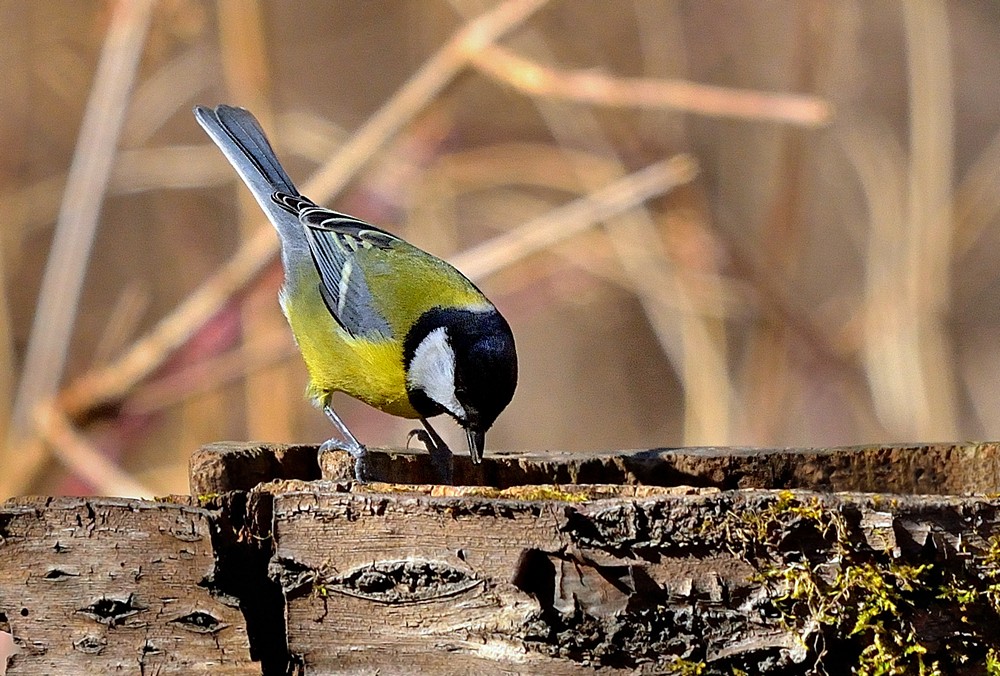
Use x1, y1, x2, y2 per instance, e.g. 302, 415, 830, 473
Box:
0, 443, 1000, 676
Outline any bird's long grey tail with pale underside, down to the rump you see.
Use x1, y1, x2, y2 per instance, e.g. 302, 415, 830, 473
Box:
194, 106, 304, 244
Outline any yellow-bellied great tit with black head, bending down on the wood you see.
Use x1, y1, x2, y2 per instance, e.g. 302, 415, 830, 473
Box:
194, 105, 517, 481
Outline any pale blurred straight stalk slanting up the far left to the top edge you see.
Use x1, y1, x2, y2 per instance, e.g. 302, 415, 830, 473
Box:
0, 0, 154, 495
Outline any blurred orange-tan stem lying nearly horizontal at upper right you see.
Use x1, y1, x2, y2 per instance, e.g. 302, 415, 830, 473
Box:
473, 45, 832, 127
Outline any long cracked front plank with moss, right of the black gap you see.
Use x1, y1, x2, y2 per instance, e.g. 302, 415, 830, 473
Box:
256, 482, 1000, 674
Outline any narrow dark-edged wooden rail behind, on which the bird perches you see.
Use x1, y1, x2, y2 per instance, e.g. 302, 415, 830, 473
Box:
191, 442, 1000, 495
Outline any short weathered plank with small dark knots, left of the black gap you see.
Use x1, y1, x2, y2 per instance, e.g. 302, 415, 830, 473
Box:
0, 498, 254, 676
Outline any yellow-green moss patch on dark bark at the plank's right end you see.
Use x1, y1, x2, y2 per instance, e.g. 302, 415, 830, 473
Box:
716, 492, 1000, 676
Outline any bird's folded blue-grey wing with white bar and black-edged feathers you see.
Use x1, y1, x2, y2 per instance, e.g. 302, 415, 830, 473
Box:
273, 193, 402, 340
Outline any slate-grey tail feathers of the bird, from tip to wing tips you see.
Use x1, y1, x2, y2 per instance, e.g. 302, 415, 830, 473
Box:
194, 106, 299, 198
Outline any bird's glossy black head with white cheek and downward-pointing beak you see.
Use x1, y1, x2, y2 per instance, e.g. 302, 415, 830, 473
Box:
403, 307, 517, 462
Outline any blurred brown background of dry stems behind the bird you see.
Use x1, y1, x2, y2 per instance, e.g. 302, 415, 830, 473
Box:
0, 0, 1000, 496
